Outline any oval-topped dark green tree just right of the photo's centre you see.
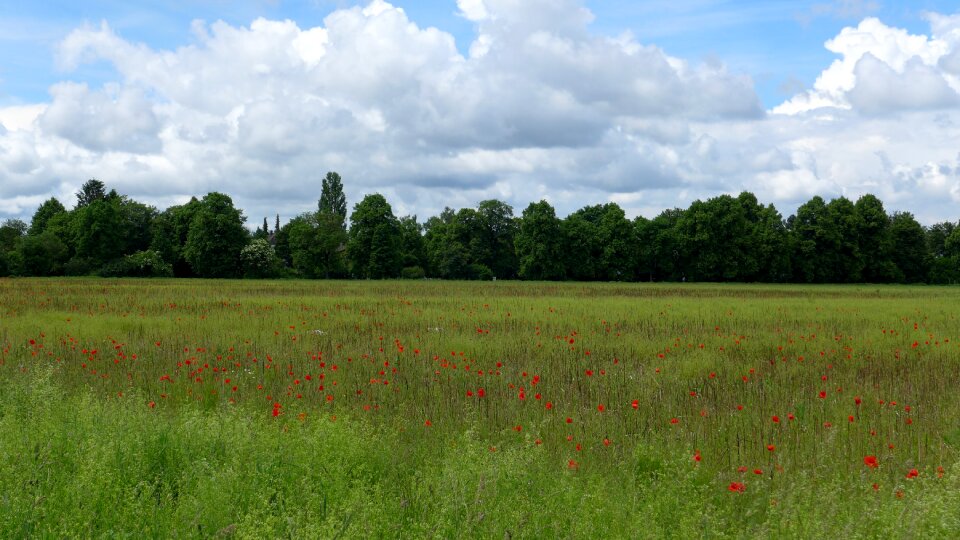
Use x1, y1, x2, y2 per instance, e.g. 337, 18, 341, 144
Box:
515, 200, 565, 280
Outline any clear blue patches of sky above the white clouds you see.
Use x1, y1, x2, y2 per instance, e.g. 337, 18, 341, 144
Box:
0, 0, 956, 107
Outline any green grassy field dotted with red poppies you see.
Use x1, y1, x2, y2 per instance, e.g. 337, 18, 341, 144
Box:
0, 279, 960, 538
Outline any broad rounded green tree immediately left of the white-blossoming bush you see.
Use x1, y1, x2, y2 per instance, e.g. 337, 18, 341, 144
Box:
183, 192, 249, 278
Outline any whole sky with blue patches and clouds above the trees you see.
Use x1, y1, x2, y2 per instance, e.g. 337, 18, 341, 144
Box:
0, 0, 960, 227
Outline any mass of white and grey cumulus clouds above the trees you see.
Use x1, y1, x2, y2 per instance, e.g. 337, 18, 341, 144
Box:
0, 0, 960, 228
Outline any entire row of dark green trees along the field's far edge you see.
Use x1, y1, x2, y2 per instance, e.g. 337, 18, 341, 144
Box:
0, 172, 960, 284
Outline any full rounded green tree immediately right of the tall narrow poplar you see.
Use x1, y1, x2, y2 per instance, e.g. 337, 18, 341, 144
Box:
347, 193, 402, 279
